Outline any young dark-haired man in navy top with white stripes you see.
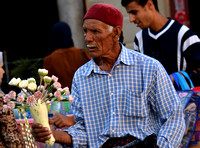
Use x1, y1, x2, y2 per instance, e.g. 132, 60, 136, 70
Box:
121, 0, 200, 86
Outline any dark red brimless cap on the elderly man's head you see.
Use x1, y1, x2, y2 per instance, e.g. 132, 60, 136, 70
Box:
83, 3, 123, 28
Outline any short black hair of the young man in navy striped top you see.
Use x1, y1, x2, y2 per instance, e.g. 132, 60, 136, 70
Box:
121, 0, 159, 11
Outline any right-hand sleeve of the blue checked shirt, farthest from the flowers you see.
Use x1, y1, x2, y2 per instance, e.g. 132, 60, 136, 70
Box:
151, 63, 185, 148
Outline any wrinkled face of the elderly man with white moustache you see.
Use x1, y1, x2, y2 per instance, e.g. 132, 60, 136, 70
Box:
83, 19, 113, 57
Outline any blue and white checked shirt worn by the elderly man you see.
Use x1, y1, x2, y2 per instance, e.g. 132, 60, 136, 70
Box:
67, 45, 185, 148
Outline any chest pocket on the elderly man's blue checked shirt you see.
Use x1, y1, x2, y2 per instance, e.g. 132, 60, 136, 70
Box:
123, 90, 148, 117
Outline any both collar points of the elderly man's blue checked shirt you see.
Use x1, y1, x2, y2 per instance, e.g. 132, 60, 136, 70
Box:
85, 43, 134, 76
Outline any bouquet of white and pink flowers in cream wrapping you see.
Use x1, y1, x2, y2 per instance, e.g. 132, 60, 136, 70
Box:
3, 69, 73, 147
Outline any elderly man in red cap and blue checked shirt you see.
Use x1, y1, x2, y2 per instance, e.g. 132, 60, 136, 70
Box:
32, 3, 185, 148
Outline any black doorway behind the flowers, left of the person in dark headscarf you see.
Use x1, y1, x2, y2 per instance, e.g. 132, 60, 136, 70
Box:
0, 0, 59, 93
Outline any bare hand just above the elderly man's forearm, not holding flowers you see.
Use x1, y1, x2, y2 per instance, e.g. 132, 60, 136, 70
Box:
49, 114, 76, 128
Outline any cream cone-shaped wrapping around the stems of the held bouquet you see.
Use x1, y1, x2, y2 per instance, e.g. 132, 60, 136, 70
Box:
30, 99, 55, 146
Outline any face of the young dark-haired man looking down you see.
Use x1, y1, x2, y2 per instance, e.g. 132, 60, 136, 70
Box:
125, 1, 152, 29
